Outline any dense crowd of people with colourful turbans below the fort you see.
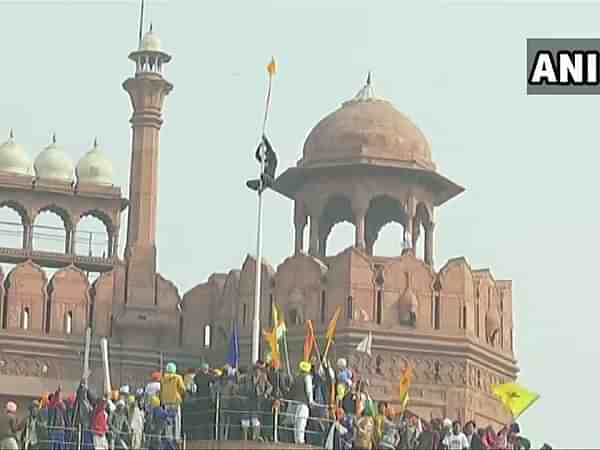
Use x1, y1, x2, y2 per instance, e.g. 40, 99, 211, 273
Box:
0, 358, 551, 450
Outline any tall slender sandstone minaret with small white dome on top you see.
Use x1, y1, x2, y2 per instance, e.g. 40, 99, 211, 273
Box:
123, 25, 173, 306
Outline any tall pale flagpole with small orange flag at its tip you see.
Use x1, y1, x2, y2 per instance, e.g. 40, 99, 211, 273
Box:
252, 58, 276, 364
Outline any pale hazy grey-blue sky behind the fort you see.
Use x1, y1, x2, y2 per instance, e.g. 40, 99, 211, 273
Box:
0, 0, 600, 448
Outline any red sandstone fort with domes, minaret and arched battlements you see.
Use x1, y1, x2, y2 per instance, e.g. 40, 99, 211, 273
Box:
0, 25, 518, 425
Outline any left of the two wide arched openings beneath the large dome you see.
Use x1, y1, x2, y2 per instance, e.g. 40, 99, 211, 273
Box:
319, 195, 356, 256
